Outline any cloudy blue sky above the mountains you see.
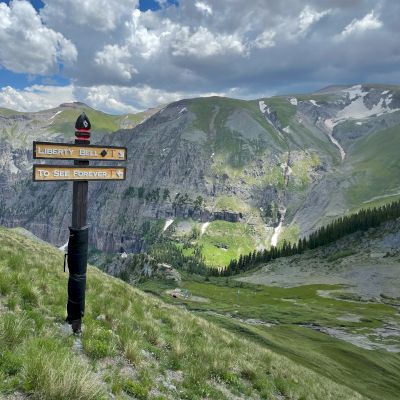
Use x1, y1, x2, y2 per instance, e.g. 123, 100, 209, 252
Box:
0, 0, 400, 114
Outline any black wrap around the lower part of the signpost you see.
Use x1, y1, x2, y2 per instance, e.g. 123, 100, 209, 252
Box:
67, 226, 89, 324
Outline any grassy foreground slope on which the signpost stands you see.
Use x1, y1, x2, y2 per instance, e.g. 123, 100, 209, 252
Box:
0, 228, 362, 400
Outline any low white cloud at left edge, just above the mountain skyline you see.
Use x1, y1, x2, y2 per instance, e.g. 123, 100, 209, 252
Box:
0, 85, 76, 111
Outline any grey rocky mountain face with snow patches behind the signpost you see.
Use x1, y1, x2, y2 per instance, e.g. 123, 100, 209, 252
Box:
0, 85, 400, 265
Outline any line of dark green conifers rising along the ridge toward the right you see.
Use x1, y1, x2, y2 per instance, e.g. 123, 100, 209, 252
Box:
152, 201, 400, 276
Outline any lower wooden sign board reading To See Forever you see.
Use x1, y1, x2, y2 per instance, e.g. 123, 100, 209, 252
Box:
33, 164, 126, 182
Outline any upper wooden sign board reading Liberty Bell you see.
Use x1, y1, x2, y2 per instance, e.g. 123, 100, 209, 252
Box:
33, 142, 127, 161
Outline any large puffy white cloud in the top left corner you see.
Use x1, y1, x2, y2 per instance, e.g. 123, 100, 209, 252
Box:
0, 0, 77, 75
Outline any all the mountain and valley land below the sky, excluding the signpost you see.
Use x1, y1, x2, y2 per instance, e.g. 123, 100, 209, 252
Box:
0, 84, 400, 400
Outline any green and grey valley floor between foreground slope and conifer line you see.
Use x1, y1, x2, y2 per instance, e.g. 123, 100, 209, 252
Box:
140, 219, 400, 400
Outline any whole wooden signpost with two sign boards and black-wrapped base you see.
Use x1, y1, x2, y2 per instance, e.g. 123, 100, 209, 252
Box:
33, 113, 127, 333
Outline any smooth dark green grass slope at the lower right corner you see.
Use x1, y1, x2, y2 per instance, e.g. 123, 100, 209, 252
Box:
207, 316, 400, 400
